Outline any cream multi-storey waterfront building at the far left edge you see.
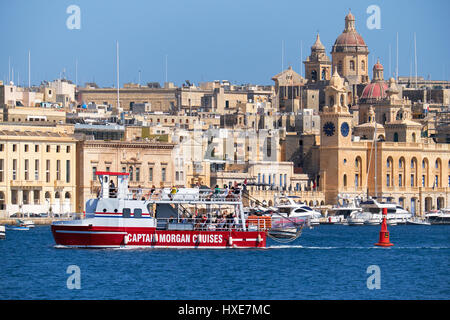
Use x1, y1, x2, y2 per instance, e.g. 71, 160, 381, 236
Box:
0, 124, 77, 216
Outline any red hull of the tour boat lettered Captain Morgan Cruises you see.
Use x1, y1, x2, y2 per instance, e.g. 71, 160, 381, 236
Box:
52, 225, 266, 249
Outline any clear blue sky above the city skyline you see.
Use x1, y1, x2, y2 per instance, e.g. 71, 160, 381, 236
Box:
0, 0, 450, 86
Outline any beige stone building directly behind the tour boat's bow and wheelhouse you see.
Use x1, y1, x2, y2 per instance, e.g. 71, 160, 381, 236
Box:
76, 140, 175, 212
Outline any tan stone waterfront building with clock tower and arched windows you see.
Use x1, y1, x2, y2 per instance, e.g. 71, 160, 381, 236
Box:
320, 73, 450, 215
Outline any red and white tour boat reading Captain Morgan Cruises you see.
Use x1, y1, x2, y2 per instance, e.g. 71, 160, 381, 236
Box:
51, 172, 280, 248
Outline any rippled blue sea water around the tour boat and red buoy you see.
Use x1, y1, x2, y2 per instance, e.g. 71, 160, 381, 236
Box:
0, 225, 450, 300
